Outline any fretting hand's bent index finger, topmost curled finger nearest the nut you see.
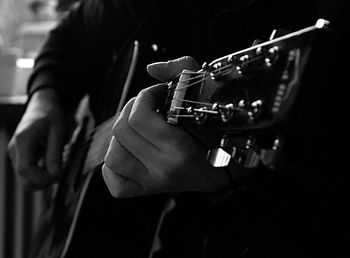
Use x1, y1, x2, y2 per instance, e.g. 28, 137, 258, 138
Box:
128, 85, 193, 151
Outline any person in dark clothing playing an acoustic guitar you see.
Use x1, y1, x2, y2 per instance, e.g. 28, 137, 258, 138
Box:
9, 0, 348, 258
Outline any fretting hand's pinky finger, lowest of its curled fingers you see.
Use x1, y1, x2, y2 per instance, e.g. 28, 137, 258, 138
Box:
102, 164, 144, 198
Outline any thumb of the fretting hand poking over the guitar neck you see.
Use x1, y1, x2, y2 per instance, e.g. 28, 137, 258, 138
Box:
147, 56, 200, 82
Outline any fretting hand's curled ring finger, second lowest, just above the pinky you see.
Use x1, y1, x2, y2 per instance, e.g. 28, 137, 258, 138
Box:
104, 136, 149, 185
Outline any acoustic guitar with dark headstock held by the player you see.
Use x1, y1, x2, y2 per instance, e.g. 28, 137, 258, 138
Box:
30, 19, 329, 258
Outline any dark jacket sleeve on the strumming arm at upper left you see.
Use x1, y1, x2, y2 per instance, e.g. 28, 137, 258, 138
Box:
28, 0, 139, 111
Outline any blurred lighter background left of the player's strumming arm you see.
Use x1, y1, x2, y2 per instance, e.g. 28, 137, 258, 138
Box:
0, 0, 340, 258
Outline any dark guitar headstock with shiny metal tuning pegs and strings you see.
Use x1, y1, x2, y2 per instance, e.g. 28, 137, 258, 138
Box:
165, 19, 328, 167
